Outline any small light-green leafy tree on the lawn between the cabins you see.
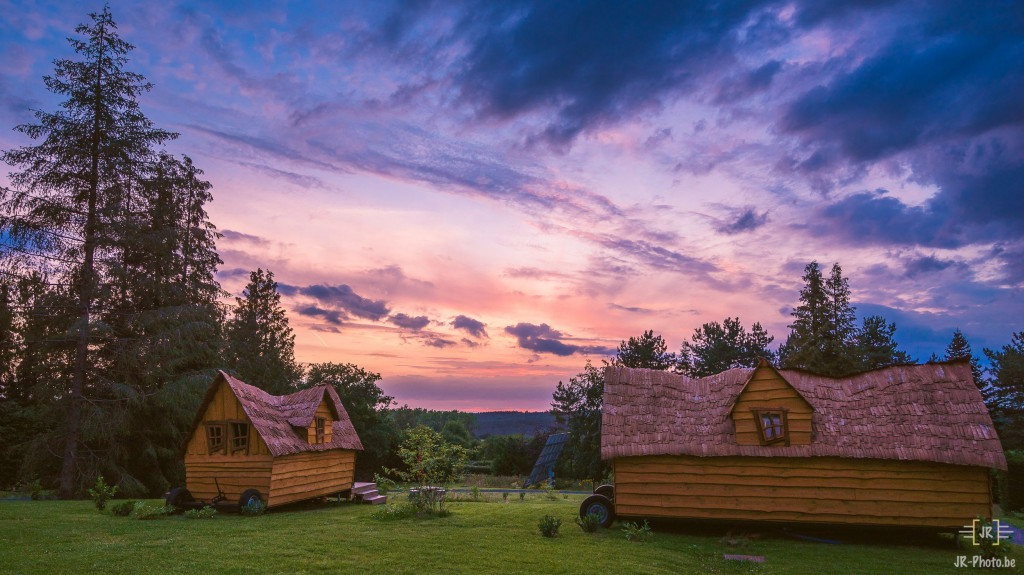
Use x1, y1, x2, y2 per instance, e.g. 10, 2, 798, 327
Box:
397, 426, 468, 513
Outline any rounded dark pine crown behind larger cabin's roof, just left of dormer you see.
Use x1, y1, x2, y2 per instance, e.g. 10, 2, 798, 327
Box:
676, 317, 775, 378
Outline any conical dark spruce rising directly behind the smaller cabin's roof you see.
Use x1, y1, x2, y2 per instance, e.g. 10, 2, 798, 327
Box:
224, 269, 302, 395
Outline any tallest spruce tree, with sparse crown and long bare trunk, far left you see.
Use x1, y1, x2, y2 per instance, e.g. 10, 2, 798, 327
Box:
0, 6, 175, 496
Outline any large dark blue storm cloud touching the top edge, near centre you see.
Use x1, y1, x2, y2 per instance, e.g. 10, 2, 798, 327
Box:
456, 1, 770, 145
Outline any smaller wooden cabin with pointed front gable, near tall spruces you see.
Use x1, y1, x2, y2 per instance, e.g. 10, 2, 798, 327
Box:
178, 371, 362, 507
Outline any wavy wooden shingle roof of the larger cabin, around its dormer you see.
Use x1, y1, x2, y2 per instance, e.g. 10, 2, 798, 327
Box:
601, 361, 1007, 470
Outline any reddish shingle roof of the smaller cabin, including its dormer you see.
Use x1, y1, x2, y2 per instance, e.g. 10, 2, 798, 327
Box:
183, 371, 362, 457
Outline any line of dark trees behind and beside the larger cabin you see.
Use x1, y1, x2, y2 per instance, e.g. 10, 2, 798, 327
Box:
551, 262, 1024, 480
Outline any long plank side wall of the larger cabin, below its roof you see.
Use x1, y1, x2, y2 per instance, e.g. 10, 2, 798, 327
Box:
613, 455, 992, 528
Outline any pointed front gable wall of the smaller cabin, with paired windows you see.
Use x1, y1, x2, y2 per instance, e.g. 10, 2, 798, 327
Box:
185, 382, 273, 503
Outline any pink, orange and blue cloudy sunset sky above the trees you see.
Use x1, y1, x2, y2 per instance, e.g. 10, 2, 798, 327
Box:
0, 0, 1024, 410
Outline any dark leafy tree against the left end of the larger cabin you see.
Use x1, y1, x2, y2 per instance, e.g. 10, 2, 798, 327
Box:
551, 361, 608, 479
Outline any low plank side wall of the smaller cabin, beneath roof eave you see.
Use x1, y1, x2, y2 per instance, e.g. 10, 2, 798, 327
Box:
267, 449, 355, 505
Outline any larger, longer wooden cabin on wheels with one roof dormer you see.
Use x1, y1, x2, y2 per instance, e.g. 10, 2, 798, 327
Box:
601, 361, 1007, 529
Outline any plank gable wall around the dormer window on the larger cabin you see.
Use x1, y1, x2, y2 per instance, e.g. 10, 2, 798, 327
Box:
732, 367, 811, 446
